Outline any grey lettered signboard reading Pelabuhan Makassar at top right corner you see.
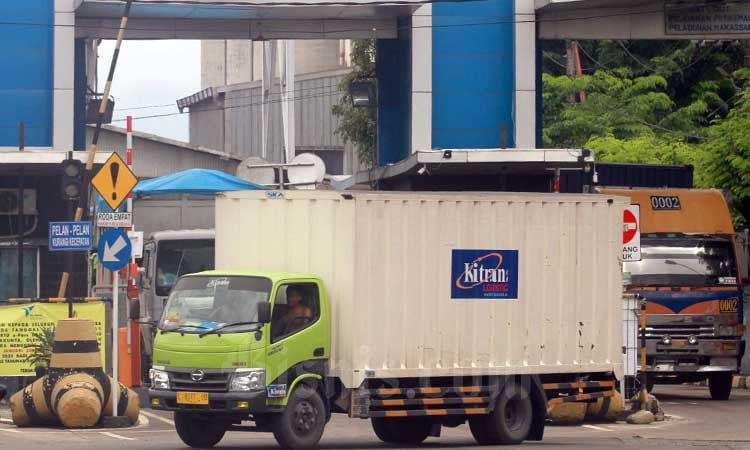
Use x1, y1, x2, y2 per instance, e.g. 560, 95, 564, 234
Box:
664, 2, 750, 35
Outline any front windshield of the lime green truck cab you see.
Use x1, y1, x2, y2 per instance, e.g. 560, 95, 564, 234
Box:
159, 276, 271, 333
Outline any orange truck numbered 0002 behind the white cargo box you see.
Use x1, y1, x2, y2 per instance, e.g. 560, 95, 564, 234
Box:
603, 189, 745, 400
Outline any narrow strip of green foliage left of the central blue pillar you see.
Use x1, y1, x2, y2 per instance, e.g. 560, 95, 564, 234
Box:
332, 39, 377, 167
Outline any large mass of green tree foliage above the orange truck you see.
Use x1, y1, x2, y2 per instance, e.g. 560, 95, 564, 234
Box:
542, 41, 750, 226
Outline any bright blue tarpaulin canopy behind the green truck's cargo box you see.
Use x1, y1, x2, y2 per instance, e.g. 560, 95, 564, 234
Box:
133, 169, 266, 198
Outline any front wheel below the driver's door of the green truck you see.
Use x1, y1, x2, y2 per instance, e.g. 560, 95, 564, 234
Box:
273, 385, 326, 450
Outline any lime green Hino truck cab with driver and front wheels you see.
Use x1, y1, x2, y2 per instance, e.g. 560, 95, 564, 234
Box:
149, 271, 330, 448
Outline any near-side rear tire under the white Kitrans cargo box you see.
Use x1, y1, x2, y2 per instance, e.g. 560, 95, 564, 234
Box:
469, 383, 534, 445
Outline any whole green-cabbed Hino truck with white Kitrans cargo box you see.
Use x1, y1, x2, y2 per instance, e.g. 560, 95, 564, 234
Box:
149, 191, 627, 450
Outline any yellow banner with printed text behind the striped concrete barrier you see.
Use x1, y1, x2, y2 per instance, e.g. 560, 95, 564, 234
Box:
0, 302, 105, 377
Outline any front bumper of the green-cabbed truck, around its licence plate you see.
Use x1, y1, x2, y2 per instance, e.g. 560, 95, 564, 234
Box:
148, 389, 276, 415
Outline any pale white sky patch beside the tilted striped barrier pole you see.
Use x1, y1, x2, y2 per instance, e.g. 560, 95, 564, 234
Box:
98, 40, 201, 142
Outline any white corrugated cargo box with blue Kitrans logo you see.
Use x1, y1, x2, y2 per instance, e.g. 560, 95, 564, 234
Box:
216, 191, 629, 387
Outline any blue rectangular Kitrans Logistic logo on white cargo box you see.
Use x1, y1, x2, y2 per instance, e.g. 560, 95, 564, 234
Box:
451, 250, 518, 300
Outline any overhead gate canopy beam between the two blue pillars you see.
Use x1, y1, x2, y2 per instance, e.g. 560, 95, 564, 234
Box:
76, 0, 431, 39
